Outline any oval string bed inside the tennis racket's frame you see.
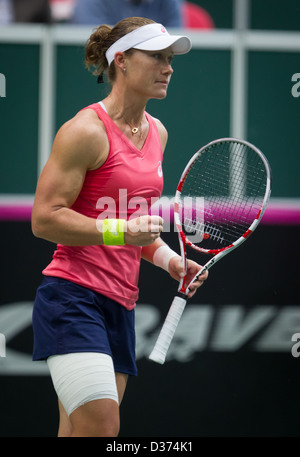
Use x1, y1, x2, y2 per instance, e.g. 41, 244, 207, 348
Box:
180, 142, 266, 249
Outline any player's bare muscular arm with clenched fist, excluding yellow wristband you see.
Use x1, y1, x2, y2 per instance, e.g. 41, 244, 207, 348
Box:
32, 110, 162, 246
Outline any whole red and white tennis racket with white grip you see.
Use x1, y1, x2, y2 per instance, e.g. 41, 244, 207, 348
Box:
149, 138, 271, 364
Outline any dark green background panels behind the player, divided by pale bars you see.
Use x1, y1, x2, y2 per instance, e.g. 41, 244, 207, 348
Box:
0, 0, 300, 197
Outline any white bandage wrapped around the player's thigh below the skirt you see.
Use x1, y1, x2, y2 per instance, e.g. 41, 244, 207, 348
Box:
47, 352, 119, 416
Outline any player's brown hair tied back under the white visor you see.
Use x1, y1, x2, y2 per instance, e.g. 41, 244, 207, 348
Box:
85, 17, 155, 82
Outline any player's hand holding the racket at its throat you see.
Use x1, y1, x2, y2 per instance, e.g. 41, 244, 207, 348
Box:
169, 256, 208, 298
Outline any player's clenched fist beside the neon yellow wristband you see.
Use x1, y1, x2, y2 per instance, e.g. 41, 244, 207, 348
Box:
124, 215, 163, 246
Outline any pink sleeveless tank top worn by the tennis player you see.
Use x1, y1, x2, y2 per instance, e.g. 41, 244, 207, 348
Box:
43, 103, 163, 309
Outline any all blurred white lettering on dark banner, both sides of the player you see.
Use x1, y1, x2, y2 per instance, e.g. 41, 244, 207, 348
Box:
0, 302, 300, 375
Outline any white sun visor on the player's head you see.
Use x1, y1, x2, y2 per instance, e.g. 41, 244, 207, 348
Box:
105, 23, 192, 65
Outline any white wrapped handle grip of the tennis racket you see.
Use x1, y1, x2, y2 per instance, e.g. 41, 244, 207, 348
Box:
149, 296, 187, 365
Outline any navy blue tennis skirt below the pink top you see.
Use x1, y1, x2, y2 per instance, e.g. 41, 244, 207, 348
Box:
32, 276, 137, 376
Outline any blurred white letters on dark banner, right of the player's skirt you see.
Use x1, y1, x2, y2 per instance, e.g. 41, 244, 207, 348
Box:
137, 305, 300, 362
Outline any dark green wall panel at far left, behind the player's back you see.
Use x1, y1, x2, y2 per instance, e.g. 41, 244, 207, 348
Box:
0, 44, 39, 194
